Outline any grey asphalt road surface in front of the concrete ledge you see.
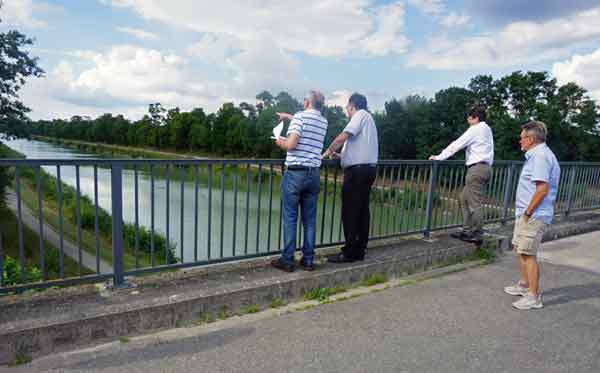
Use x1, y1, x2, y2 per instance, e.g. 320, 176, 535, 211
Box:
5, 232, 600, 373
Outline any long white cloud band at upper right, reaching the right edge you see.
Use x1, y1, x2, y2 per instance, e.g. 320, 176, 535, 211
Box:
408, 8, 600, 70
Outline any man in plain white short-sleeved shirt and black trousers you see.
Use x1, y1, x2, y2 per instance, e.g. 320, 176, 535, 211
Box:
323, 93, 379, 263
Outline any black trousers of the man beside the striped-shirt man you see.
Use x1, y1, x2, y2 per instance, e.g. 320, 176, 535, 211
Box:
342, 165, 377, 259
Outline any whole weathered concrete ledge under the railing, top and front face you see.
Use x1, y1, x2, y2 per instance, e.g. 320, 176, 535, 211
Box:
0, 214, 600, 363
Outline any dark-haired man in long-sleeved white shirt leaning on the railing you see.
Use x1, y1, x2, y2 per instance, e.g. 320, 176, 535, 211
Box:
429, 106, 494, 244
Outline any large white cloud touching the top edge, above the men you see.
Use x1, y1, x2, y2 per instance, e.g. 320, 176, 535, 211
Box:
103, 0, 406, 57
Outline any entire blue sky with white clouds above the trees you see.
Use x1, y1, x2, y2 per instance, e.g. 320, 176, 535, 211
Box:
0, 0, 600, 119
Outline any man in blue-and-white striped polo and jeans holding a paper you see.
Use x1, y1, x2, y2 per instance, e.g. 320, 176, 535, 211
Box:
271, 91, 327, 272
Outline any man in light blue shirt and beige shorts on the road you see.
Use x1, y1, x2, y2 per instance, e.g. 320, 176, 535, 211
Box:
504, 121, 560, 310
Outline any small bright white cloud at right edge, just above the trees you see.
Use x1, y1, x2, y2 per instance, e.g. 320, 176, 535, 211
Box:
552, 49, 600, 101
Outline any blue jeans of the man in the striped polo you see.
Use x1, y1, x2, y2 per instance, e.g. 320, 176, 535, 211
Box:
281, 167, 321, 264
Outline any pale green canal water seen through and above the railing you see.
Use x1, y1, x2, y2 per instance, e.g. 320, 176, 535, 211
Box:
2, 139, 343, 262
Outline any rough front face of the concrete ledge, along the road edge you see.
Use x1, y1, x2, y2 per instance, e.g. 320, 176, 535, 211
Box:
0, 215, 600, 363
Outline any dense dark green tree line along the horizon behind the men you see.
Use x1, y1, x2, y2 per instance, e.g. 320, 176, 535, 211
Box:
21, 71, 600, 161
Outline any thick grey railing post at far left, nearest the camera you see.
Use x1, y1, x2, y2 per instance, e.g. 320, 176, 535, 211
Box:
110, 163, 125, 288
